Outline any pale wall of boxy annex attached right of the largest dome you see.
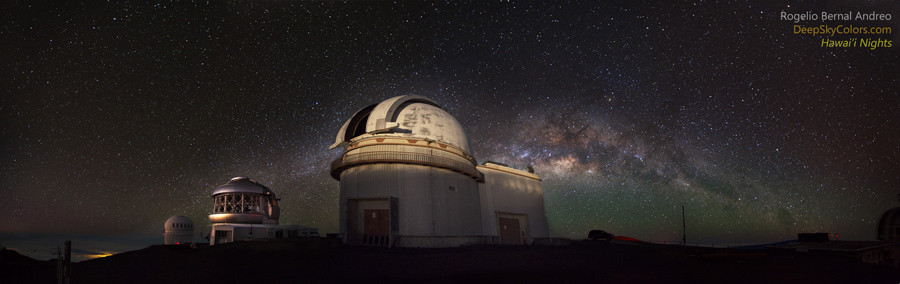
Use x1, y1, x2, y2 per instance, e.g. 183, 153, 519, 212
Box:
478, 165, 550, 239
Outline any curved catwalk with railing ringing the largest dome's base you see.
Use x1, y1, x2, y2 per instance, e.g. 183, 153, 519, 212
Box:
331, 152, 484, 181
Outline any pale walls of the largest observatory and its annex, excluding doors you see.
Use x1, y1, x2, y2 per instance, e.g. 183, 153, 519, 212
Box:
340, 163, 550, 247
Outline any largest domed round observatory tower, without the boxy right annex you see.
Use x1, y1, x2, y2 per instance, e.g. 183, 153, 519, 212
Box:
331, 96, 484, 246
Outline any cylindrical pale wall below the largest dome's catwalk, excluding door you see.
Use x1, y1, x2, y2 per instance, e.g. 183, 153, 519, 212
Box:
340, 163, 482, 243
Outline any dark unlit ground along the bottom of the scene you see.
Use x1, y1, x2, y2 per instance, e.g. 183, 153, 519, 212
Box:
0, 239, 900, 284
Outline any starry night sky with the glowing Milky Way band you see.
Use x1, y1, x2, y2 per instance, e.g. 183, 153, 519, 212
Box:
0, 1, 900, 260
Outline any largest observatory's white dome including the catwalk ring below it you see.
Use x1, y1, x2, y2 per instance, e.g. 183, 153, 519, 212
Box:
329, 96, 483, 181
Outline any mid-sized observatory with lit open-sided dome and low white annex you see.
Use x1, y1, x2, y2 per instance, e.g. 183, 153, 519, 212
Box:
209, 177, 319, 245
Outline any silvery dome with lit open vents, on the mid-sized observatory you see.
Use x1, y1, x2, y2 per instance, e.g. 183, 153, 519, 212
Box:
209, 177, 280, 224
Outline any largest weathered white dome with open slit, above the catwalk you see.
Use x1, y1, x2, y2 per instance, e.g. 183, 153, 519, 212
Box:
331, 96, 472, 155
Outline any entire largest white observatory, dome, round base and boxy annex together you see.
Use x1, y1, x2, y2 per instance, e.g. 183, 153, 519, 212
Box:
330, 96, 549, 247
